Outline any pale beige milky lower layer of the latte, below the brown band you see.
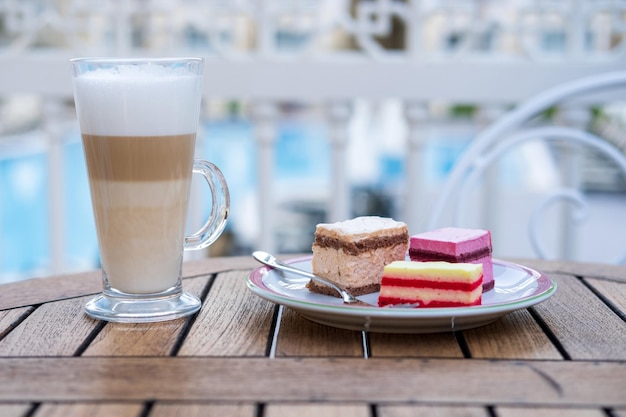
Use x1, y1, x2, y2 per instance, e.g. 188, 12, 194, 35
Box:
91, 178, 190, 294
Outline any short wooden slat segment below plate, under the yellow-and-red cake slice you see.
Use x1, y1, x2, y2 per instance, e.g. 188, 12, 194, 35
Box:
368, 333, 463, 358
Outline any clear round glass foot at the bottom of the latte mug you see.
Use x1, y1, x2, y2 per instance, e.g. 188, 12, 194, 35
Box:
85, 291, 201, 323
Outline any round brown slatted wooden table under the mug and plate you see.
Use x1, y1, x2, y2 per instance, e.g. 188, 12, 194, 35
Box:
0, 257, 626, 417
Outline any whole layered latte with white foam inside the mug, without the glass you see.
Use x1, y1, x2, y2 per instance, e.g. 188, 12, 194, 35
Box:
74, 65, 200, 294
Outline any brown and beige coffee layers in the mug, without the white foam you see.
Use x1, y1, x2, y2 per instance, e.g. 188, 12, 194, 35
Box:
83, 134, 195, 293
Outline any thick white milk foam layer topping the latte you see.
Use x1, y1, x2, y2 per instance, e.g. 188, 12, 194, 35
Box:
74, 64, 202, 136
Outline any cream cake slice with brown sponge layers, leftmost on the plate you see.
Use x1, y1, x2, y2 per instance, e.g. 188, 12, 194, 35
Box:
307, 216, 409, 296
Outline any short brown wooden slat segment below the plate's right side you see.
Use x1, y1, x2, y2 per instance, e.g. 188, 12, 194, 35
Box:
463, 310, 562, 359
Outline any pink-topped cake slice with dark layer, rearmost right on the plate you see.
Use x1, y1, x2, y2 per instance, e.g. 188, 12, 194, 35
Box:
409, 227, 495, 291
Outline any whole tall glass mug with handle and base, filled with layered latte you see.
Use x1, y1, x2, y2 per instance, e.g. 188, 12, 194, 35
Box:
70, 58, 230, 322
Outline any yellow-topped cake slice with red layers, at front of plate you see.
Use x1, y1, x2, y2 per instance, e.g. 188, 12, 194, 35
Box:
378, 261, 483, 307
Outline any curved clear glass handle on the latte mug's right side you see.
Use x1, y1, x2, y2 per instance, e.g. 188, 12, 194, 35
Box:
183, 159, 230, 250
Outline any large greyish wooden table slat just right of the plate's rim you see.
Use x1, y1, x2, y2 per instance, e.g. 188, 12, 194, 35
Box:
534, 275, 626, 360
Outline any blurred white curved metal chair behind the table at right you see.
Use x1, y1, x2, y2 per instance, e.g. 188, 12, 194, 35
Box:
427, 71, 626, 263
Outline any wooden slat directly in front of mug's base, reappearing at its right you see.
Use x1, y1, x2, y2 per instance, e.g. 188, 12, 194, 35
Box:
83, 276, 209, 356
